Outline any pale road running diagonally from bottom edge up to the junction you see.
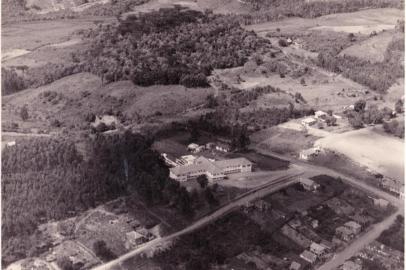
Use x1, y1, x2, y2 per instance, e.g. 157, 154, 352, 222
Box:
94, 174, 300, 270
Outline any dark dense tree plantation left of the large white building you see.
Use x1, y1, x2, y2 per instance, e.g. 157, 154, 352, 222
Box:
2, 132, 193, 264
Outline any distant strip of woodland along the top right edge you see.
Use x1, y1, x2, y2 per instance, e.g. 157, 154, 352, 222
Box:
238, 0, 403, 25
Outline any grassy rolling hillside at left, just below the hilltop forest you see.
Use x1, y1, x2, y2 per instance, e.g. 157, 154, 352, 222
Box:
2, 73, 213, 133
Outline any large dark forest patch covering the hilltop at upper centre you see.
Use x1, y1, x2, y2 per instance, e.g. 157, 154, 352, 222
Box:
81, 6, 270, 87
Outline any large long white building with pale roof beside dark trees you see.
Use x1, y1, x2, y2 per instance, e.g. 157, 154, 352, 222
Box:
170, 157, 252, 182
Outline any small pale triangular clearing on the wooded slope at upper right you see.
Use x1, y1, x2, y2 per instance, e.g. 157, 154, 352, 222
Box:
339, 31, 402, 62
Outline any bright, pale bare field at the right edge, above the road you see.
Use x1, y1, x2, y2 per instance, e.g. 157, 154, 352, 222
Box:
315, 128, 404, 181
